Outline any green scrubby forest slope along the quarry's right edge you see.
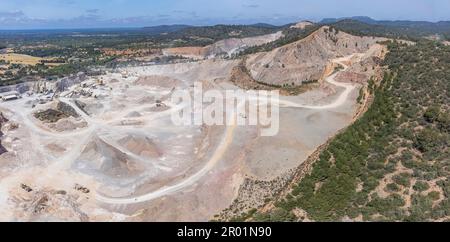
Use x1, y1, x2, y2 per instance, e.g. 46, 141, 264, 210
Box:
243, 41, 450, 221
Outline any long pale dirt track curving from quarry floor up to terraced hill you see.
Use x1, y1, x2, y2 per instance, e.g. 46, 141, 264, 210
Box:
96, 55, 356, 205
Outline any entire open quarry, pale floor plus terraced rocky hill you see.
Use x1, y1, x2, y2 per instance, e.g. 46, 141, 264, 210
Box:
0, 23, 386, 221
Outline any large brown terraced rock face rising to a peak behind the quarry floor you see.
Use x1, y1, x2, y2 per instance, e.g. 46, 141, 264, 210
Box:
246, 26, 386, 85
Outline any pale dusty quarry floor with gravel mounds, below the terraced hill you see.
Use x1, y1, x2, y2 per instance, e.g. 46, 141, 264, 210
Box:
0, 29, 384, 221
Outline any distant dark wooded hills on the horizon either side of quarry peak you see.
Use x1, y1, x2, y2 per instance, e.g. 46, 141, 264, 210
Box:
141, 16, 450, 39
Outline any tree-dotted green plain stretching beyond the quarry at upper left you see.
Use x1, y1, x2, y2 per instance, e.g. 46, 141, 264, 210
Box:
0, 24, 281, 85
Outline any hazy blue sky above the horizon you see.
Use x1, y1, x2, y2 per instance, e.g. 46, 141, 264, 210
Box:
0, 0, 450, 29
